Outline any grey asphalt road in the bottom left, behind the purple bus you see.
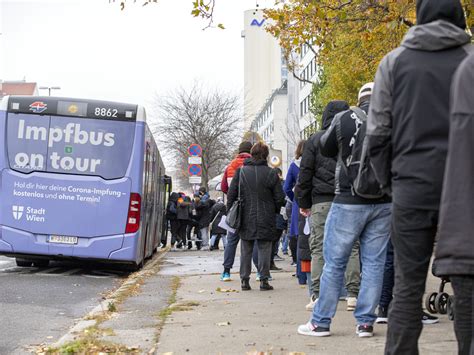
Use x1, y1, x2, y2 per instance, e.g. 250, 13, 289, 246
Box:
0, 256, 128, 355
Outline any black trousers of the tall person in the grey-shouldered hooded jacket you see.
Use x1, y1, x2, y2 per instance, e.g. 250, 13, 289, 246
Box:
385, 204, 438, 355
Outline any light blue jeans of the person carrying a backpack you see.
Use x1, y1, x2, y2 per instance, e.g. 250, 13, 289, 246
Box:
311, 203, 392, 327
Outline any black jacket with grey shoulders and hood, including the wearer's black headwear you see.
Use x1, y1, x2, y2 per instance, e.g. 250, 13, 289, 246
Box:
367, 0, 473, 210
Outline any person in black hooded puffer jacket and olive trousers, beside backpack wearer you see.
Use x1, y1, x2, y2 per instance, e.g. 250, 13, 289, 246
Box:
295, 101, 360, 310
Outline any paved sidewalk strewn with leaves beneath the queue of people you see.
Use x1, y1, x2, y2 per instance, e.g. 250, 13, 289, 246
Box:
80, 251, 457, 355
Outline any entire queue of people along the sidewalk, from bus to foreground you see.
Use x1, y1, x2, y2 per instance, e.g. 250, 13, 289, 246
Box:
164, 0, 474, 355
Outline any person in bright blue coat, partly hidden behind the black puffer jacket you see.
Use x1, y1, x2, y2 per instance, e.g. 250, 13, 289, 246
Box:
283, 140, 307, 285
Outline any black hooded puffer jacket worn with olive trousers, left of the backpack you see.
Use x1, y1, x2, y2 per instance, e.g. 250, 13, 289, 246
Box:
295, 101, 349, 209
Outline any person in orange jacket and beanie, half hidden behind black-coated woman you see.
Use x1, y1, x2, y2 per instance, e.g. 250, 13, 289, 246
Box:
221, 141, 253, 281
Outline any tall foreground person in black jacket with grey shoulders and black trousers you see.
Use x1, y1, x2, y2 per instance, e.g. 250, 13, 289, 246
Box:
367, 0, 473, 355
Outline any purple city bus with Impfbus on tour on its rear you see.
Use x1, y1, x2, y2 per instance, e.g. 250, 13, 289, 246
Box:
0, 96, 170, 269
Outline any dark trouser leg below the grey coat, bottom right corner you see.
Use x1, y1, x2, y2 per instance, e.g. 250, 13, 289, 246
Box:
450, 275, 474, 355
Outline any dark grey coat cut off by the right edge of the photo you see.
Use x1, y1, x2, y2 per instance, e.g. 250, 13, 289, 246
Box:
433, 54, 474, 276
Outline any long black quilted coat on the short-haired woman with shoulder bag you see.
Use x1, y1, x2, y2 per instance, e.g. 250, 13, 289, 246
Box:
227, 159, 285, 241
